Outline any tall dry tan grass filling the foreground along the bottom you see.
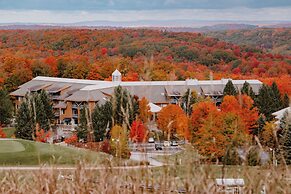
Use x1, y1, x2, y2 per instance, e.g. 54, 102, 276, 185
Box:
0, 160, 291, 194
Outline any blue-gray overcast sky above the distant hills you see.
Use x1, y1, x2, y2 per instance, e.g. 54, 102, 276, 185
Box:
0, 0, 291, 23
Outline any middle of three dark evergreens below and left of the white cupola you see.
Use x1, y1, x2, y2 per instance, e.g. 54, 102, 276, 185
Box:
92, 101, 112, 142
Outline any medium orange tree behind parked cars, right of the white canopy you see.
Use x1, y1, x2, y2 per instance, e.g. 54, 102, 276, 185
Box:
157, 104, 190, 139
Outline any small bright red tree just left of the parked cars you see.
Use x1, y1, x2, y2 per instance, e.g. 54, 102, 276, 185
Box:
129, 120, 148, 143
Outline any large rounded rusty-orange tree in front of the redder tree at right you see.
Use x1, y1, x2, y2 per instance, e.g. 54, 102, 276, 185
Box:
194, 112, 248, 163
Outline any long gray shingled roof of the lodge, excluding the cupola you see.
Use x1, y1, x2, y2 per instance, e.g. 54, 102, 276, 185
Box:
11, 77, 262, 103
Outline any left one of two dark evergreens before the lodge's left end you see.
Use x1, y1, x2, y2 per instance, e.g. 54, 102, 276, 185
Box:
15, 96, 35, 140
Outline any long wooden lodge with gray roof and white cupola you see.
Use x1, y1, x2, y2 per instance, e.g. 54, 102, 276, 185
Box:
10, 70, 262, 125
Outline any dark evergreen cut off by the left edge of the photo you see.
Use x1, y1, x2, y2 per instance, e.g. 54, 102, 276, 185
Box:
0, 90, 13, 126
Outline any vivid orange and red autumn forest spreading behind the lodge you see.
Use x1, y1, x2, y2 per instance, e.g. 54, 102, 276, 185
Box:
0, 29, 291, 95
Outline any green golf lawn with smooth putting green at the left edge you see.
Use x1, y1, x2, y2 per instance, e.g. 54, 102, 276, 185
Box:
0, 139, 133, 166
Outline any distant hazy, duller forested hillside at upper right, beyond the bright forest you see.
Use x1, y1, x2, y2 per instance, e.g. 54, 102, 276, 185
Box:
207, 28, 291, 55
